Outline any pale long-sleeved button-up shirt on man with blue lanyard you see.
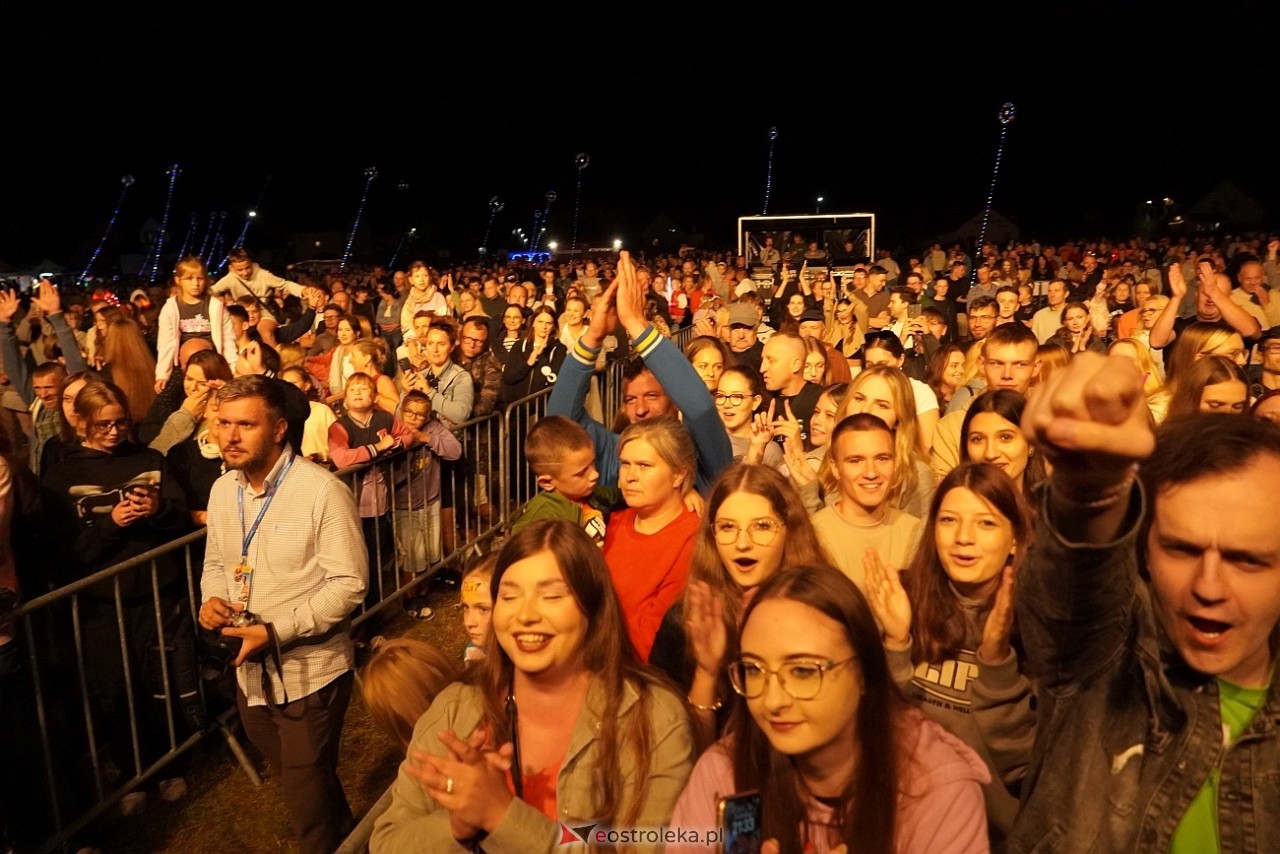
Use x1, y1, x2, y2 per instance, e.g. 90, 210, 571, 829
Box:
200, 446, 369, 705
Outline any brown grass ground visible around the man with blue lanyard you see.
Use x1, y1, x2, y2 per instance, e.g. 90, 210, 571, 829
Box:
90, 589, 466, 854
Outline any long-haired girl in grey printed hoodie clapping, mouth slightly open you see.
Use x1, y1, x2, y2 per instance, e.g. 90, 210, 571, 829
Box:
865, 462, 1036, 846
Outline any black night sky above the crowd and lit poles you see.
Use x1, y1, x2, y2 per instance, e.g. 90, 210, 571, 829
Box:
0, 0, 1280, 266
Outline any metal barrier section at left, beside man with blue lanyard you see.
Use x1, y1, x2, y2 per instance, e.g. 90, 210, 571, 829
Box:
5, 529, 260, 851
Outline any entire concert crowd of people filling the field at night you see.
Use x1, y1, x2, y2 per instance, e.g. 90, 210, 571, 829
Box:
0, 234, 1280, 853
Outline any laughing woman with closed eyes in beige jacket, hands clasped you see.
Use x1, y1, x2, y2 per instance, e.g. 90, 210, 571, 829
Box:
370, 520, 694, 854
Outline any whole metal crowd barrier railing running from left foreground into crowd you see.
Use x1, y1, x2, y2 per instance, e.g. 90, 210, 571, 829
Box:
0, 323, 691, 851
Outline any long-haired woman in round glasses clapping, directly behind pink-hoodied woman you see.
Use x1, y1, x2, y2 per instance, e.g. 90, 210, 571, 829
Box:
649, 465, 831, 741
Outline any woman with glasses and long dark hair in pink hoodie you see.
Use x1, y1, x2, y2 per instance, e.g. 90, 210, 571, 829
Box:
667, 565, 989, 854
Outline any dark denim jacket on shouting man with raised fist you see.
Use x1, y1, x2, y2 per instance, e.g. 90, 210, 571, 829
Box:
1009, 485, 1280, 854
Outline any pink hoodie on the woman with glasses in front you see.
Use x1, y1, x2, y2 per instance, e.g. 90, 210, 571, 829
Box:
666, 709, 991, 854
